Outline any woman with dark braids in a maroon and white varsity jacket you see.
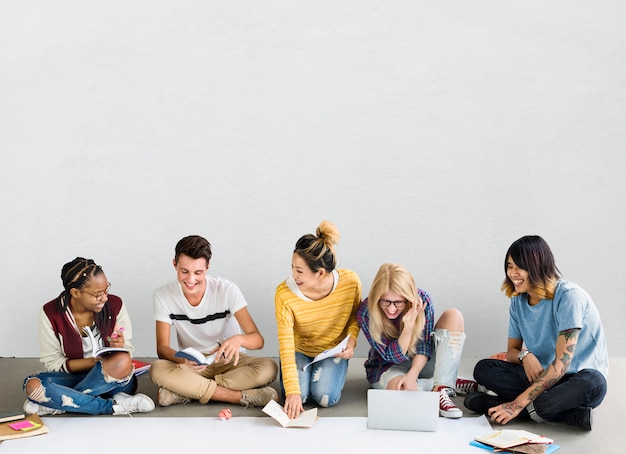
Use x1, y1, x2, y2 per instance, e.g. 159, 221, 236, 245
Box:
24, 257, 154, 415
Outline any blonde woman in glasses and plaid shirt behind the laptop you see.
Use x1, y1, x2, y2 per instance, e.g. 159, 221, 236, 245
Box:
357, 263, 477, 418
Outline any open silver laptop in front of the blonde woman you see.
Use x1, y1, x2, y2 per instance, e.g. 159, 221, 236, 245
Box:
367, 389, 439, 432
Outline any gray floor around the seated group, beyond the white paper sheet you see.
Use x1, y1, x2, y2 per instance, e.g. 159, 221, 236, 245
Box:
0, 358, 626, 453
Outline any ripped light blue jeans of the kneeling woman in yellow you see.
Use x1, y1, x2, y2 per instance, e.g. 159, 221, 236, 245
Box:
279, 352, 348, 407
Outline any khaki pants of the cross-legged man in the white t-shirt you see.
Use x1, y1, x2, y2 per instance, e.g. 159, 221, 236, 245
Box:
150, 353, 278, 404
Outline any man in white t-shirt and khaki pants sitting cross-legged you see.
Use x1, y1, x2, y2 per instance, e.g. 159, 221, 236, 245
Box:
150, 235, 278, 407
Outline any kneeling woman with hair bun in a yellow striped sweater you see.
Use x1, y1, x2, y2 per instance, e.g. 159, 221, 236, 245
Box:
274, 221, 361, 418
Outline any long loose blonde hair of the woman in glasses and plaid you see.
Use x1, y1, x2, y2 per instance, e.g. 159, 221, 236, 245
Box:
367, 263, 426, 356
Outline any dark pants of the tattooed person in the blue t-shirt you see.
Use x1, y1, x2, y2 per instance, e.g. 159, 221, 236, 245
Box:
474, 359, 607, 421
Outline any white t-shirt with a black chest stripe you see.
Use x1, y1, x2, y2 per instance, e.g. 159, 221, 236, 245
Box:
153, 275, 248, 354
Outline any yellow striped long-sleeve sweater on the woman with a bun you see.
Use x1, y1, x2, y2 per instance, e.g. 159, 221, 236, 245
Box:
274, 269, 361, 395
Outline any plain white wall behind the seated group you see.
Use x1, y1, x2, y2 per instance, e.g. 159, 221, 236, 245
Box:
0, 0, 626, 357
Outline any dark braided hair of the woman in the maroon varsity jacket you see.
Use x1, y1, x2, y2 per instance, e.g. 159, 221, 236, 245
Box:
56, 257, 115, 333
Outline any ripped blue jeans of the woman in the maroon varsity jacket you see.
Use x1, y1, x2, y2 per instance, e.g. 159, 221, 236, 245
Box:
23, 362, 137, 415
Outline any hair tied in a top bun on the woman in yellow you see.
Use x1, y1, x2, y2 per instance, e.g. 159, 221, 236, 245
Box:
293, 221, 339, 273
